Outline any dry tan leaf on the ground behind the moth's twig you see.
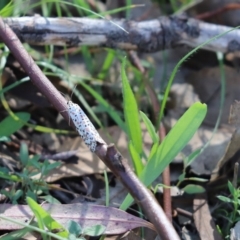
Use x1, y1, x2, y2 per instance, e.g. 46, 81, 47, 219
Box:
45, 124, 152, 182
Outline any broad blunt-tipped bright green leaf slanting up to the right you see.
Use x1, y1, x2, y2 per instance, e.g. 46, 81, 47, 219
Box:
120, 102, 207, 210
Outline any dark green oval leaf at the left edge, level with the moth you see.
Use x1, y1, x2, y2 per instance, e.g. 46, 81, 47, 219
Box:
0, 112, 30, 137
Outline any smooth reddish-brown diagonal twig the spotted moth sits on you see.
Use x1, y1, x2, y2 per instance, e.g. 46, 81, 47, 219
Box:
0, 18, 180, 240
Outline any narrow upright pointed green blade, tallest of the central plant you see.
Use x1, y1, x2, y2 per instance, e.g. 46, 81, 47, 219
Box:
121, 59, 142, 154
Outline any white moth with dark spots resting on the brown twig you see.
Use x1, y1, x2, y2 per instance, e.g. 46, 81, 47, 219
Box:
67, 101, 104, 152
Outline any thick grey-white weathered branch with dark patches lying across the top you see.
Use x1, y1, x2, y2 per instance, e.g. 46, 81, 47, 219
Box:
4, 16, 240, 53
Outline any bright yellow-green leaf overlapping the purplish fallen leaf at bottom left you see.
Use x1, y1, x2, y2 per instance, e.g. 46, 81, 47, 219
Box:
27, 197, 69, 237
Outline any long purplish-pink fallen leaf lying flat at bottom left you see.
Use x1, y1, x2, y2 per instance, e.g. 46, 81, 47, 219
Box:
0, 203, 154, 234
